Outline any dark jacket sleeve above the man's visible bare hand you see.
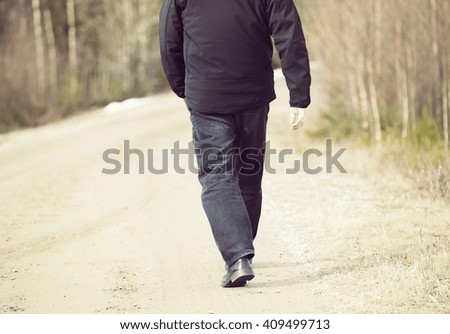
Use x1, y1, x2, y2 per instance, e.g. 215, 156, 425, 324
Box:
267, 0, 311, 108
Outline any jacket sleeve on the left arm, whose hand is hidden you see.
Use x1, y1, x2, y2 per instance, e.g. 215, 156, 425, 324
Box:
159, 0, 185, 98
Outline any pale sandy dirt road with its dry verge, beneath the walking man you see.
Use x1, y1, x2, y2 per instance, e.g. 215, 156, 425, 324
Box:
0, 70, 450, 313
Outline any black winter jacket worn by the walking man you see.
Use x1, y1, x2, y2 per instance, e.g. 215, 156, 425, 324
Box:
160, 0, 311, 113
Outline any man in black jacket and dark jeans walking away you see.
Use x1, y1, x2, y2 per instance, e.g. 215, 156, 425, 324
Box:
160, 0, 311, 287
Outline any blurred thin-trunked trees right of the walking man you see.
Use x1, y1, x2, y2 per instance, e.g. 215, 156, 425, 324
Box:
305, 0, 450, 148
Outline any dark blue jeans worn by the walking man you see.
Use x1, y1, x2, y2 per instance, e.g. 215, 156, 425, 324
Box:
190, 105, 269, 265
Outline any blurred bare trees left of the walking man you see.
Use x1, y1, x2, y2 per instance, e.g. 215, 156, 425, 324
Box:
0, 0, 163, 132
